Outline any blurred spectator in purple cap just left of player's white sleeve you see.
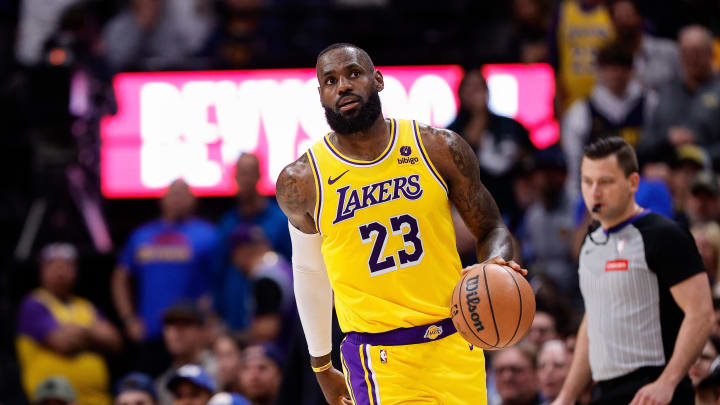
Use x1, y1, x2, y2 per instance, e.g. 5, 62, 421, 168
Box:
230, 225, 297, 351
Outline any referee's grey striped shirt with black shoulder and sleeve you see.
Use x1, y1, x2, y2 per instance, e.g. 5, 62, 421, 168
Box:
579, 210, 704, 381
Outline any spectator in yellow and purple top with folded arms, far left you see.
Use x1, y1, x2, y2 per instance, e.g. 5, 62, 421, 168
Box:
16, 243, 122, 405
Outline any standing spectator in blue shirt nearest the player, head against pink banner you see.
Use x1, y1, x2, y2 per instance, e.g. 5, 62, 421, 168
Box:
213, 153, 292, 330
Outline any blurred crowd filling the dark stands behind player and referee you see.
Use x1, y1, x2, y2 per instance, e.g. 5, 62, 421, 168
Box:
0, 0, 720, 405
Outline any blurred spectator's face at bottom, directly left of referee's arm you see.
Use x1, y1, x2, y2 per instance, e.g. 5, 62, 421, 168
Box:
537, 340, 572, 403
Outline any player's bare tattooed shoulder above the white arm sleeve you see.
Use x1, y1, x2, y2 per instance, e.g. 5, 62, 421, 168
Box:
275, 154, 315, 216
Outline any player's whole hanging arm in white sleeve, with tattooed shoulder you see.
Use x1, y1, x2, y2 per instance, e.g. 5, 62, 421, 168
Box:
275, 155, 352, 405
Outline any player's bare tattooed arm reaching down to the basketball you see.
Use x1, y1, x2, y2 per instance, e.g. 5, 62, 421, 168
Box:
420, 126, 519, 268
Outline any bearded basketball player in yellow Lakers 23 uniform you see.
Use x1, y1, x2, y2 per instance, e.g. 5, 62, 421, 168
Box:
277, 44, 527, 405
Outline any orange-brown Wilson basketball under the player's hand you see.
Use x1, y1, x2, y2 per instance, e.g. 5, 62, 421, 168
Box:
450, 264, 535, 350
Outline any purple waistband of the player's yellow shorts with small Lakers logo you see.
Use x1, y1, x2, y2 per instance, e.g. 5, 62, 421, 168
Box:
345, 318, 457, 346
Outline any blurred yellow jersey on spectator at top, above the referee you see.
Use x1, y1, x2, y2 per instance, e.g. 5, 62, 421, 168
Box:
557, 0, 613, 108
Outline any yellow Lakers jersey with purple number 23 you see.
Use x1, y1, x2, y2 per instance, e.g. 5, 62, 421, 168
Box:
308, 119, 461, 333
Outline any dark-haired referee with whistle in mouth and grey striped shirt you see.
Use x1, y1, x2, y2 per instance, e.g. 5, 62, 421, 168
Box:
553, 137, 714, 405
